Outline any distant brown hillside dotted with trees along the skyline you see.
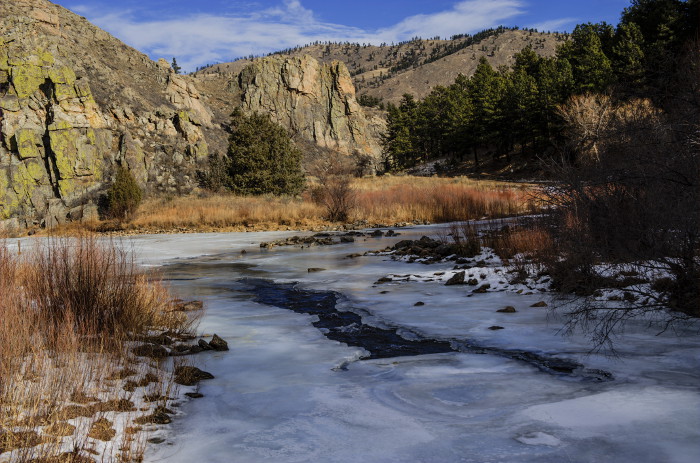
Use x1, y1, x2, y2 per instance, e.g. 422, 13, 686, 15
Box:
194, 29, 567, 103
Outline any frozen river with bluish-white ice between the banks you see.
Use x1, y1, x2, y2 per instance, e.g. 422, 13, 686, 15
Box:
119, 227, 700, 463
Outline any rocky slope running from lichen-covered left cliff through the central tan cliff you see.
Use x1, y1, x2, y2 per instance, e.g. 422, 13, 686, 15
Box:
0, 0, 379, 232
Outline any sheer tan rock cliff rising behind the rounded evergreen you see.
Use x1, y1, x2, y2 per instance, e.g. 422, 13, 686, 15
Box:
237, 56, 381, 158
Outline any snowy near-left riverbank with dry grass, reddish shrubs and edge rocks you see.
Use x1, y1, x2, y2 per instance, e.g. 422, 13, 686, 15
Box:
0, 237, 211, 463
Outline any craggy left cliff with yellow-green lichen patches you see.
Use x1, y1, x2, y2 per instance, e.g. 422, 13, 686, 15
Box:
0, 0, 212, 228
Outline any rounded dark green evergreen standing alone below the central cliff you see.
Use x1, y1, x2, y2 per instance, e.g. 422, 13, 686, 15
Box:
226, 109, 304, 195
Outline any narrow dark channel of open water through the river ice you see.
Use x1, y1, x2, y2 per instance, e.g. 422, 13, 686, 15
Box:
241, 278, 613, 381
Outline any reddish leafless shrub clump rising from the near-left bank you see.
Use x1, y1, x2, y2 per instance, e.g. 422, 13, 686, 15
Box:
26, 235, 174, 344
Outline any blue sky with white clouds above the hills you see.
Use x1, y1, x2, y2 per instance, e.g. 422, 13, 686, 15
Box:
53, 0, 630, 71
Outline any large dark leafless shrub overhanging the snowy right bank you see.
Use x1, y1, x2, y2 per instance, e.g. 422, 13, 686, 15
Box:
543, 92, 700, 346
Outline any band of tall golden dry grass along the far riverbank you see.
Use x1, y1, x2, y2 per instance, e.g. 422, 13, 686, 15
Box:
68, 176, 536, 234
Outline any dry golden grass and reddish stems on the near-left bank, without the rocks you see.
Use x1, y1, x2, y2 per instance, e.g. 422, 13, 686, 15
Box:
0, 237, 197, 462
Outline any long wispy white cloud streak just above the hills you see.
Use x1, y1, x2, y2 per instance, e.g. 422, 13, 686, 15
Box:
81, 0, 525, 70
